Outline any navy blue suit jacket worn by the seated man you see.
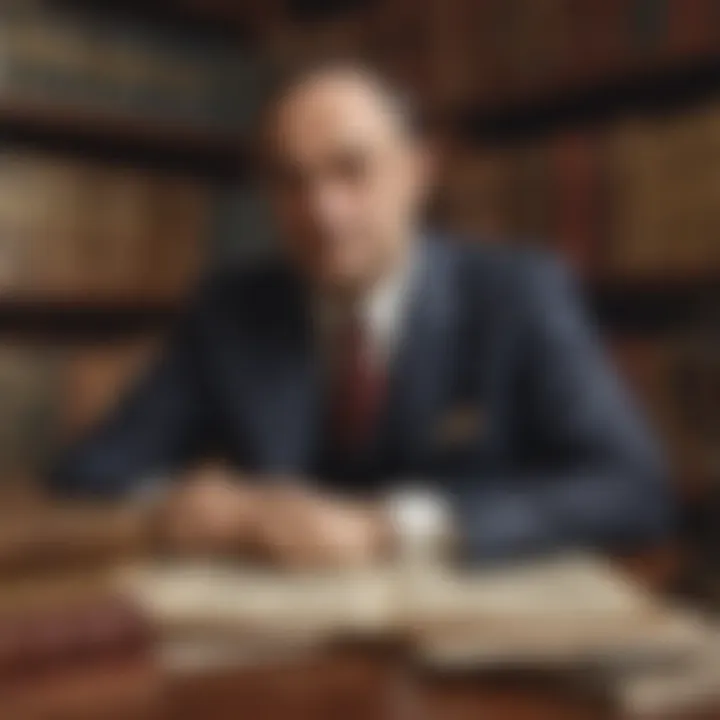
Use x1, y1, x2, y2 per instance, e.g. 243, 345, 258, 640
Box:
52, 240, 671, 558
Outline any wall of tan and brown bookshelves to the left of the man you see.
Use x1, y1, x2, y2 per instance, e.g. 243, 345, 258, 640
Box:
0, 0, 263, 490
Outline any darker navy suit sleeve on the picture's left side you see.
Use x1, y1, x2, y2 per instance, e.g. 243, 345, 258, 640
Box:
49, 298, 208, 498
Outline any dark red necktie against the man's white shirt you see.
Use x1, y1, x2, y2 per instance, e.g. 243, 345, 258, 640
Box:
332, 315, 385, 452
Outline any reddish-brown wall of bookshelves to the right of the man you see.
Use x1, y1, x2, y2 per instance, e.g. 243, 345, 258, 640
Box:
255, 0, 720, 504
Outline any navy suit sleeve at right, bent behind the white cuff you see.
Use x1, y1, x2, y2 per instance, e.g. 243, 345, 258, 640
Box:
450, 262, 673, 559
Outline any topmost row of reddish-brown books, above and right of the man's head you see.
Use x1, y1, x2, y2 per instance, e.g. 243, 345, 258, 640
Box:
262, 0, 720, 106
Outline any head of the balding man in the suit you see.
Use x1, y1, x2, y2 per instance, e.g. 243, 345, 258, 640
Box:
262, 63, 429, 293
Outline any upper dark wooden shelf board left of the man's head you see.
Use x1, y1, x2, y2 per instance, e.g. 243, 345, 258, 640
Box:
0, 96, 245, 176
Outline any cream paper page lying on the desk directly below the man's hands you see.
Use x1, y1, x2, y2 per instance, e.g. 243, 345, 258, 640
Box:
121, 564, 396, 634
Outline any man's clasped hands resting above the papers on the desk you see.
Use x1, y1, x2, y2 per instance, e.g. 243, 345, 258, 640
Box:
158, 469, 390, 569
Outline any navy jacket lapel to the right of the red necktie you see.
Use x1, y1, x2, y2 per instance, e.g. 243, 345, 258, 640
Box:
385, 241, 458, 473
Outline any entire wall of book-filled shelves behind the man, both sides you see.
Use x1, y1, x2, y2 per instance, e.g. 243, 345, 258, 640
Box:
0, 0, 720, 504
